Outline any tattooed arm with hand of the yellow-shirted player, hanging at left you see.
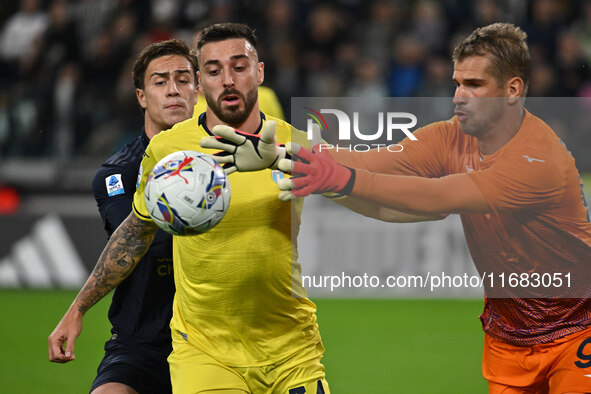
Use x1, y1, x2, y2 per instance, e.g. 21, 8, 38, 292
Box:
48, 212, 158, 363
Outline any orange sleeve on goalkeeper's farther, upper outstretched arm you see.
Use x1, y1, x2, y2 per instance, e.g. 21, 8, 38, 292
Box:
329, 118, 450, 178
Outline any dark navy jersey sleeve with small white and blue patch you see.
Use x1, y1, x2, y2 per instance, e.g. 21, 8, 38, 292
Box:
92, 166, 137, 236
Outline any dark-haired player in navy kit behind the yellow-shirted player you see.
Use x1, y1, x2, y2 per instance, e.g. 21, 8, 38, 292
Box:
50, 40, 197, 394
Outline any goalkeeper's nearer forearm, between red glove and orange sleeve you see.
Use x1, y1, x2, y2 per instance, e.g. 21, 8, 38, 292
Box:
351, 170, 491, 215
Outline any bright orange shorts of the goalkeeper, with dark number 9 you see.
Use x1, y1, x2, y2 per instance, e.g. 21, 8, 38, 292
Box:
482, 327, 591, 394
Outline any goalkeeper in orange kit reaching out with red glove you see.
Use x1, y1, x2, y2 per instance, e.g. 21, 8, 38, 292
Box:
215, 23, 591, 394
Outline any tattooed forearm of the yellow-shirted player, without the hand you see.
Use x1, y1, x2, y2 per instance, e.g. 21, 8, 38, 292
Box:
76, 212, 157, 313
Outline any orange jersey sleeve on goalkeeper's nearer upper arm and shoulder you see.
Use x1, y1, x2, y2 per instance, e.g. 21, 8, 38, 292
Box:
468, 150, 567, 213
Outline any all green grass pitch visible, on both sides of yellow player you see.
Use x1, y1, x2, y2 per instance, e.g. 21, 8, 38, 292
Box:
0, 291, 487, 394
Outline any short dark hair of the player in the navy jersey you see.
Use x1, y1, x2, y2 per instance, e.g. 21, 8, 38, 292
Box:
131, 39, 197, 89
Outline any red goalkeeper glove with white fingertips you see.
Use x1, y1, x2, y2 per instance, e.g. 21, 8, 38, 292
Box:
277, 143, 355, 201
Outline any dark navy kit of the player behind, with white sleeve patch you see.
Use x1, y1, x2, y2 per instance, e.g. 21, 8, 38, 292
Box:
92, 131, 174, 393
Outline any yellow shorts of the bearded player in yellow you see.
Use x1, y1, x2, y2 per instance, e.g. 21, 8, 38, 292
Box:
168, 330, 330, 394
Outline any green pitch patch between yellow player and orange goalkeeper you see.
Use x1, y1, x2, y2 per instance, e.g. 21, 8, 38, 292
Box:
315, 299, 488, 394
